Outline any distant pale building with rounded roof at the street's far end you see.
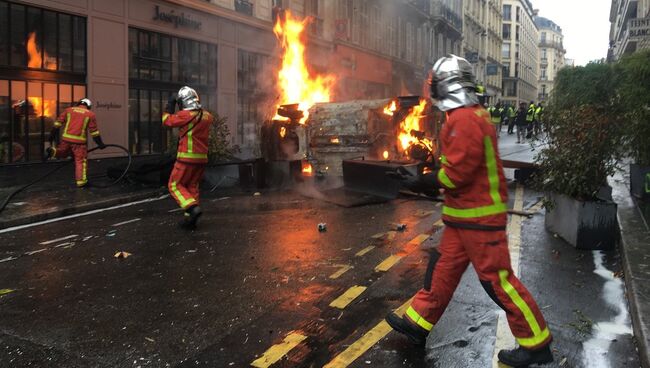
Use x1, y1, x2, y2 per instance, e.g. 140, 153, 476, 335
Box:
535, 16, 566, 101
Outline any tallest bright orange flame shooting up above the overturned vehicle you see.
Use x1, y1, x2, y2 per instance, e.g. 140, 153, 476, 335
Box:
273, 11, 336, 124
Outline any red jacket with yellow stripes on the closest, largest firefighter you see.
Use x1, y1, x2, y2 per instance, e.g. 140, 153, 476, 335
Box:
438, 105, 508, 230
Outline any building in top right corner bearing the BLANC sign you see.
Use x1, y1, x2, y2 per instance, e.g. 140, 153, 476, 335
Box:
607, 0, 650, 61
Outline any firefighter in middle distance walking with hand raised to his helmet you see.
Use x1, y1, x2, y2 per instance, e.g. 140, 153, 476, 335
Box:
162, 86, 213, 229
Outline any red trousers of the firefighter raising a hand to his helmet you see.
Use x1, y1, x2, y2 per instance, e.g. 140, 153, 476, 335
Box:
168, 161, 205, 209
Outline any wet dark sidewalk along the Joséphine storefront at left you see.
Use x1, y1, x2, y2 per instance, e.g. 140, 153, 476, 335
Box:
0, 159, 167, 229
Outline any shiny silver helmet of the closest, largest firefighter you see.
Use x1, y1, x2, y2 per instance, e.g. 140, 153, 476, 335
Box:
428, 54, 479, 111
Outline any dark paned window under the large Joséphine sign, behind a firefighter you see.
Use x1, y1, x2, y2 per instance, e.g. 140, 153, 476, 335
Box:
129, 28, 217, 154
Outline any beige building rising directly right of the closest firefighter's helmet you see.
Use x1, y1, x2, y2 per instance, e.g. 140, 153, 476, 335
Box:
463, 0, 503, 102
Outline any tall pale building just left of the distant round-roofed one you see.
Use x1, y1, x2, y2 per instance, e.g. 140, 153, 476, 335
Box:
501, 0, 539, 104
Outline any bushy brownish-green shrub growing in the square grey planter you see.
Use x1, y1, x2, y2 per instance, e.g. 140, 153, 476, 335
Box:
536, 62, 623, 200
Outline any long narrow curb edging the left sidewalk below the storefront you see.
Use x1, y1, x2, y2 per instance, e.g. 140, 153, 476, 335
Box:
0, 189, 167, 230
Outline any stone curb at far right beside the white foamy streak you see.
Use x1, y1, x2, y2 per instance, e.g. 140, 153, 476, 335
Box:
610, 175, 650, 368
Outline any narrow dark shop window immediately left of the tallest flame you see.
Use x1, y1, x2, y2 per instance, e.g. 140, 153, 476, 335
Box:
236, 50, 269, 147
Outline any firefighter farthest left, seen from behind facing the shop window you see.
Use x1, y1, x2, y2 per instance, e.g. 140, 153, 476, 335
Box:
45, 98, 106, 188
